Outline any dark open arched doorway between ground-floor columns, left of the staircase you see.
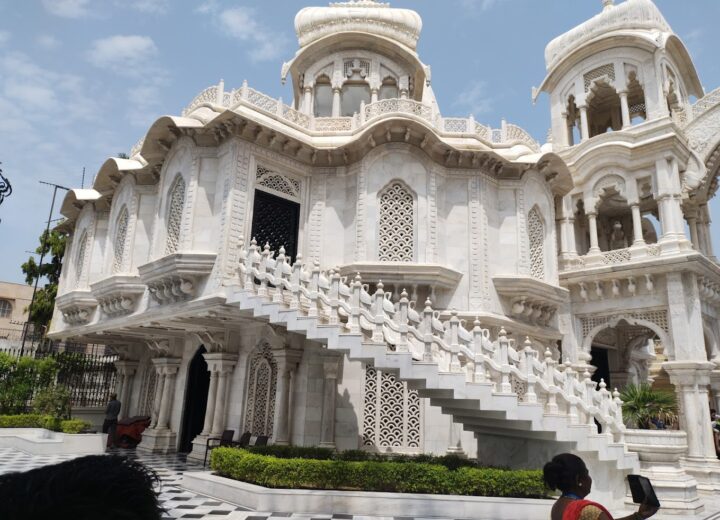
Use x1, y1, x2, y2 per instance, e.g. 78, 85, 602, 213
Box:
178, 346, 210, 453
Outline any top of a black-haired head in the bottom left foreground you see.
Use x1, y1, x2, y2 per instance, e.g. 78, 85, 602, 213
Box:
0, 455, 163, 520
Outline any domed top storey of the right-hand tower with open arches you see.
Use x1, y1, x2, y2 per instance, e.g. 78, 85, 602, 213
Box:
535, 0, 703, 146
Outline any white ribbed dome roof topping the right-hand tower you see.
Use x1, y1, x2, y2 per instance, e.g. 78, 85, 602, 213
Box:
545, 0, 672, 71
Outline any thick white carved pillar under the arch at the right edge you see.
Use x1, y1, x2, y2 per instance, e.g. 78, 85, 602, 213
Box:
662, 361, 720, 491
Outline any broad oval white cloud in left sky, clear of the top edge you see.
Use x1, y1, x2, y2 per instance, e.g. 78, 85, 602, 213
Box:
87, 35, 158, 76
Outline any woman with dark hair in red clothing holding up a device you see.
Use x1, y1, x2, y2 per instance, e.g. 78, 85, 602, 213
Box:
543, 453, 658, 520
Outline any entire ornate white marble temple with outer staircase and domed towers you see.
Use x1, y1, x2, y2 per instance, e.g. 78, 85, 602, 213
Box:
51, 0, 720, 514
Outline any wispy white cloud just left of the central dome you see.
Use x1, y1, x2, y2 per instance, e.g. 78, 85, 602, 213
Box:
197, 0, 288, 62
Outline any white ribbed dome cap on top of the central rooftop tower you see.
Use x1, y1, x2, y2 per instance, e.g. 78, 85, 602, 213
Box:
295, 0, 422, 50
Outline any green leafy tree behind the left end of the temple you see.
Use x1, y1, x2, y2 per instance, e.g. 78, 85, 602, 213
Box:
22, 231, 66, 330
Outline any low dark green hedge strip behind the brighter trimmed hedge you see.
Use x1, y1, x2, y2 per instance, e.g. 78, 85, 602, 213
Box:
245, 445, 480, 470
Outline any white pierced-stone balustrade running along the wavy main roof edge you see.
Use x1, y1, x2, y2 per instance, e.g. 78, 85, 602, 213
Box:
162, 82, 540, 152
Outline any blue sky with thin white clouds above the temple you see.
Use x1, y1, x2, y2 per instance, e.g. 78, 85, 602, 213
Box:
0, 0, 720, 283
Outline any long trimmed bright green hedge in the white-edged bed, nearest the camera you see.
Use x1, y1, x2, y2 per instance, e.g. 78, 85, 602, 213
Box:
210, 448, 547, 498
